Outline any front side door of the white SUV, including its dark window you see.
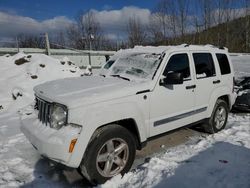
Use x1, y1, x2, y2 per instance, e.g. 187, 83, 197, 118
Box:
150, 52, 195, 136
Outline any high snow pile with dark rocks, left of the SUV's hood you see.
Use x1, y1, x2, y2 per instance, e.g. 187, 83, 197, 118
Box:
0, 52, 81, 113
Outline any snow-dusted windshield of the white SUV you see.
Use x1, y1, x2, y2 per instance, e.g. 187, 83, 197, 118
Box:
109, 53, 162, 80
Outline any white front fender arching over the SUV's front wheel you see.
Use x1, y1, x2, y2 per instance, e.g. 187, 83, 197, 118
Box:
66, 96, 149, 167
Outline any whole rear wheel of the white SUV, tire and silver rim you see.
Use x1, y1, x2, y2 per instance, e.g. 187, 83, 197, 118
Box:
203, 99, 229, 134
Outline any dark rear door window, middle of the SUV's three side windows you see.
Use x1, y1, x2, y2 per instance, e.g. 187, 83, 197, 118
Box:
193, 53, 215, 78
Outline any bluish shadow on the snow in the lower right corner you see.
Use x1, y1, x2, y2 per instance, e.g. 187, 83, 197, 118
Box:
156, 142, 250, 188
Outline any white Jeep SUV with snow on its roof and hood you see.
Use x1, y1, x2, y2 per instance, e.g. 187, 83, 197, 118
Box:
21, 45, 235, 183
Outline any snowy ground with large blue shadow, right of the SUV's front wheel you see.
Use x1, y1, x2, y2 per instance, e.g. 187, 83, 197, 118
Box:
100, 115, 250, 188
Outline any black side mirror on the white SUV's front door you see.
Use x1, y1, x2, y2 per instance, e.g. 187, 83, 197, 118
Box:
160, 72, 183, 85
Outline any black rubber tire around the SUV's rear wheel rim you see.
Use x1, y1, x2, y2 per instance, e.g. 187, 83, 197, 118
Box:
203, 99, 229, 134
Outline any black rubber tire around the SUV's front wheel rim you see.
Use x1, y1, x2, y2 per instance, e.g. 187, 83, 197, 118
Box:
78, 124, 136, 185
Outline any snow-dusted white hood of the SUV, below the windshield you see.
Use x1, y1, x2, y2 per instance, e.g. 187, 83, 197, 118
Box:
34, 76, 150, 108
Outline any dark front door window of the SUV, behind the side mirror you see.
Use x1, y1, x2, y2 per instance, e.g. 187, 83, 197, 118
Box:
164, 54, 191, 80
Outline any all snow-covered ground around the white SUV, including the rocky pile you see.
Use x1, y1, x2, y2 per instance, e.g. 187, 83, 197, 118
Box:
0, 53, 250, 188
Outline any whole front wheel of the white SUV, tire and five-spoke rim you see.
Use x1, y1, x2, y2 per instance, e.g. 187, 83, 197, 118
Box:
78, 124, 136, 185
